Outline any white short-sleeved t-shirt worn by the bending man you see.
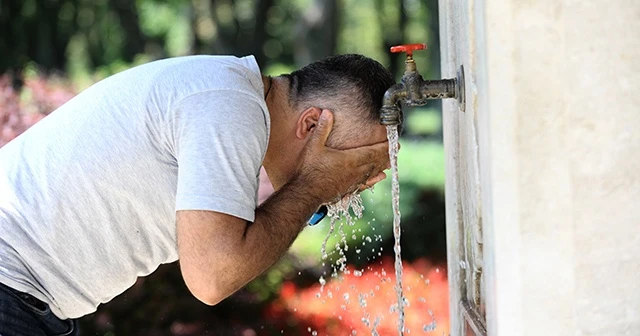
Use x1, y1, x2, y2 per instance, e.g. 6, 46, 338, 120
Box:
0, 56, 270, 319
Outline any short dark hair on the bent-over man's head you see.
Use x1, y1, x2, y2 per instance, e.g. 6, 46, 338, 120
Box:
286, 54, 395, 121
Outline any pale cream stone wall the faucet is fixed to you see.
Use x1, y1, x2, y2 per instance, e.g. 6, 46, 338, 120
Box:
439, 0, 640, 336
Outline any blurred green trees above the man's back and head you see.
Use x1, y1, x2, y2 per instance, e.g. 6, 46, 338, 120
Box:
0, 0, 439, 77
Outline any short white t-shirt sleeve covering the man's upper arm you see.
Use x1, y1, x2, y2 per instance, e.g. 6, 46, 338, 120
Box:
173, 90, 268, 222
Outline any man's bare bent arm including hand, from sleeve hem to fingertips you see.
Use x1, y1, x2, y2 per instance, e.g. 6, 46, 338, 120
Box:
177, 111, 389, 305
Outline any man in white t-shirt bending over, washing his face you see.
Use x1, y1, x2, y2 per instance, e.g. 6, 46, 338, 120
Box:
0, 55, 393, 336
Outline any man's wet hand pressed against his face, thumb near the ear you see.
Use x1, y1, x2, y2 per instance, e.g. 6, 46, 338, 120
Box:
294, 110, 389, 203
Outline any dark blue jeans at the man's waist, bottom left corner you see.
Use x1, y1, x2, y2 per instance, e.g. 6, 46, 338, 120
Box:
0, 283, 79, 336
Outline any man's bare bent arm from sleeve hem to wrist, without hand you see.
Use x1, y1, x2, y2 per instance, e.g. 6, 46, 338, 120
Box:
177, 176, 320, 305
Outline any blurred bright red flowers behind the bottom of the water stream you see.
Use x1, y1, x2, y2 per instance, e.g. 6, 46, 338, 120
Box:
272, 259, 449, 335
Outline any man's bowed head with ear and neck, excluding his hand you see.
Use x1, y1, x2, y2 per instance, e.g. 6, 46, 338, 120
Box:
263, 55, 394, 189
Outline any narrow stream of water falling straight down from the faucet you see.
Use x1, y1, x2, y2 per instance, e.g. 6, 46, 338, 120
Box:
387, 126, 405, 336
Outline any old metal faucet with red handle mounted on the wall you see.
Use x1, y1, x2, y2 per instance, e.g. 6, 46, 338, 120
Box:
380, 43, 465, 126
